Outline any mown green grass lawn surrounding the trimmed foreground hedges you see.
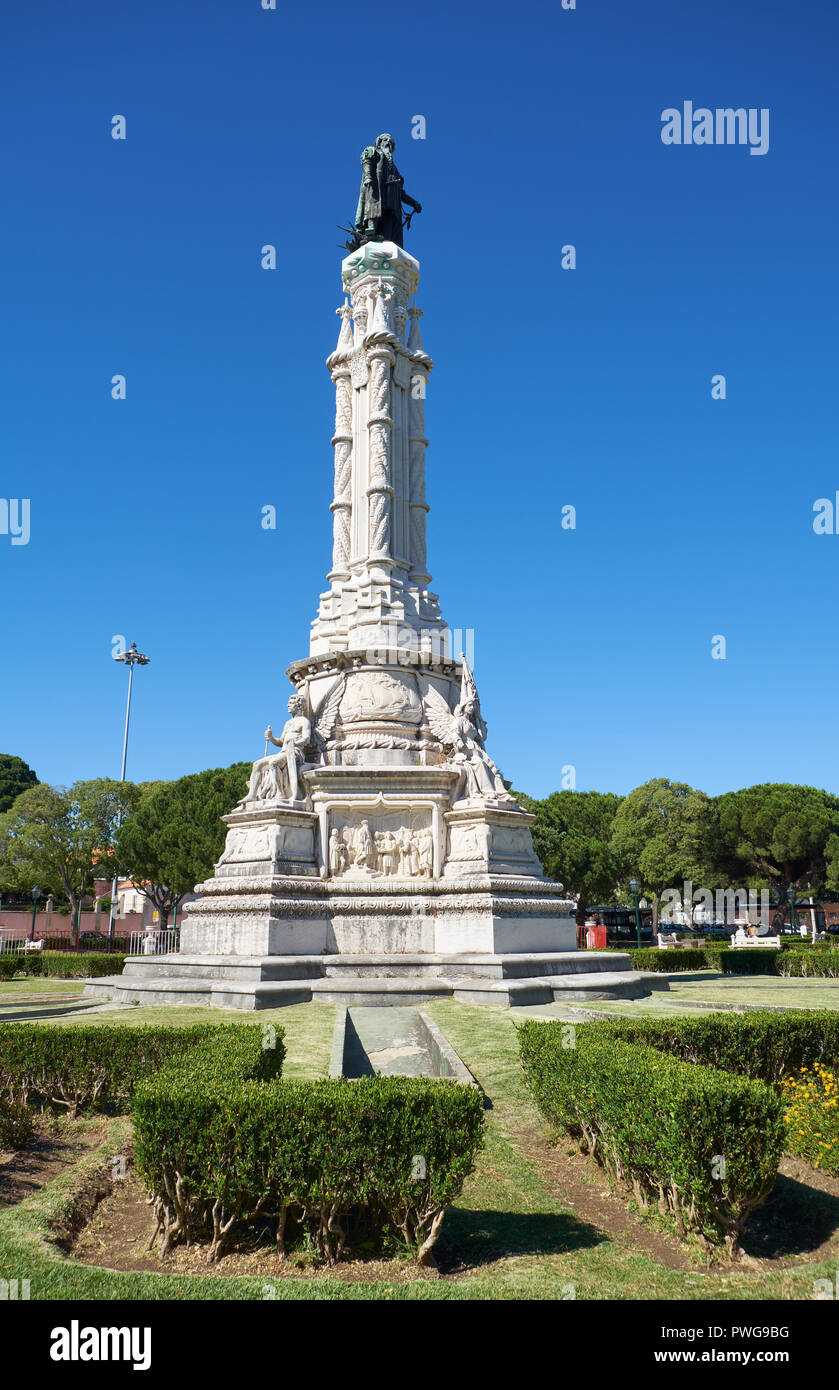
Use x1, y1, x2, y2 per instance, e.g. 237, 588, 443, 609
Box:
0, 1000, 839, 1300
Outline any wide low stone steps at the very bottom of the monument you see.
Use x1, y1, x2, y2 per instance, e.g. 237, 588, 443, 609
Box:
85, 951, 649, 1009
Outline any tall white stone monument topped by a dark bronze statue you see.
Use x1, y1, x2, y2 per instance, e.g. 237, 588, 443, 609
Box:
88, 136, 643, 1008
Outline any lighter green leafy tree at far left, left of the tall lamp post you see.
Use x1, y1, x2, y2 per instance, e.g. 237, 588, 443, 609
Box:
0, 777, 138, 941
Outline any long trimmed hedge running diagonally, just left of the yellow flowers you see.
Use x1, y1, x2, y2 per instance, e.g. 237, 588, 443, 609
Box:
518, 1020, 785, 1254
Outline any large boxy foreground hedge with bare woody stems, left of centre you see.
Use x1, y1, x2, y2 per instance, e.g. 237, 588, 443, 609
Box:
133, 1029, 483, 1264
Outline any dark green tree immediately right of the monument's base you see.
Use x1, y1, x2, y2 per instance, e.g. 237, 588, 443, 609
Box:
518, 791, 621, 926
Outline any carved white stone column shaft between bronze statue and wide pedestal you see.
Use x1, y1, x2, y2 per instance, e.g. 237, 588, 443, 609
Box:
311, 242, 446, 653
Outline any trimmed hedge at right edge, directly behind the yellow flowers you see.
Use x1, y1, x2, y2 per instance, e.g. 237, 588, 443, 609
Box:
585, 1009, 839, 1086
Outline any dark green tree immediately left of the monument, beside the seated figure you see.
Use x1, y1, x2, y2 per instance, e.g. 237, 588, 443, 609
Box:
115, 763, 251, 927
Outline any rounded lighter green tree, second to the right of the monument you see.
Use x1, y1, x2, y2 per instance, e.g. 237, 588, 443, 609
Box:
611, 777, 715, 931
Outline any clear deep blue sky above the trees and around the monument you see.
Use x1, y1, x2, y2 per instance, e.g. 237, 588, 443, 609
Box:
0, 0, 839, 795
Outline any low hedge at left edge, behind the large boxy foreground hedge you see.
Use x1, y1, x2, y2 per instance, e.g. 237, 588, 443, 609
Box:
0, 1023, 258, 1115
